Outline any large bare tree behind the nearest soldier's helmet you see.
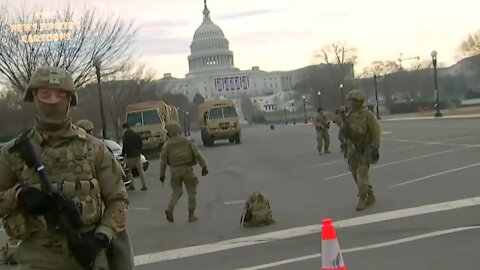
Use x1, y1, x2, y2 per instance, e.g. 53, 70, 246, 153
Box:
0, 2, 136, 92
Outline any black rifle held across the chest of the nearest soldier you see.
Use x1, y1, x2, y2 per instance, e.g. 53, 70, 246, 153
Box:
9, 130, 93, 270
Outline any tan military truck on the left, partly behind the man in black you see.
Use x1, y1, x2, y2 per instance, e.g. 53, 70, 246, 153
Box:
125, 101, 179, 153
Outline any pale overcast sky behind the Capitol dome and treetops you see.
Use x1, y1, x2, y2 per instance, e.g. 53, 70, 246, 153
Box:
6, 0, 480, 77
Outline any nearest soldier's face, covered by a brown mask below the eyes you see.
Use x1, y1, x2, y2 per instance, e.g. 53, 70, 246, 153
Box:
35, 89, 71, 122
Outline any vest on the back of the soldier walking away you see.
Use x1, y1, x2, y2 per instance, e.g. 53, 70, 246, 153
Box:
167, 137, 196, 166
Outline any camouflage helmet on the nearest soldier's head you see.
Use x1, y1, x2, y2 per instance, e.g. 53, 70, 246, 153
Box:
23, 67, 78, 106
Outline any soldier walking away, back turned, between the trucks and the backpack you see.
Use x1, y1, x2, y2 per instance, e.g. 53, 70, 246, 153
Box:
160, 122, 208, 222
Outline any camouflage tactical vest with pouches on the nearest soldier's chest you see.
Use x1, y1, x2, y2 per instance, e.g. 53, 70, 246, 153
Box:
3, 129, 103, 239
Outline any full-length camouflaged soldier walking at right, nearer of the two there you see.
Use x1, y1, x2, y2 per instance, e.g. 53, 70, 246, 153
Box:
340, 90, 381, 211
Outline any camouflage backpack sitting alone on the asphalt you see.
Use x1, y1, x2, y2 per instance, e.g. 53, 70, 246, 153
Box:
240, 191, 275, 227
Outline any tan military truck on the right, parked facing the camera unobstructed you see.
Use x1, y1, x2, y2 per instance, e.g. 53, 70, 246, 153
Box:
198, 99, 240, 146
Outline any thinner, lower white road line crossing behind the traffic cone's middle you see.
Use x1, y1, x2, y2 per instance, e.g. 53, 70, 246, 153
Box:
235, 226, 480, 270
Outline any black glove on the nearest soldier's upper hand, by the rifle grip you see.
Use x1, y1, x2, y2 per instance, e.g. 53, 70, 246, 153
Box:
17, 186, 52, 216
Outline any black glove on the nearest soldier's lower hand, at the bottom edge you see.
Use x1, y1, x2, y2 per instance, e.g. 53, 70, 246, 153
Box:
69, 231, 110, 269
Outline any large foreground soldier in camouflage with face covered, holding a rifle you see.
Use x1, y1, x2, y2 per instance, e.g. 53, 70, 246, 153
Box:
0, 67, 132, 270
